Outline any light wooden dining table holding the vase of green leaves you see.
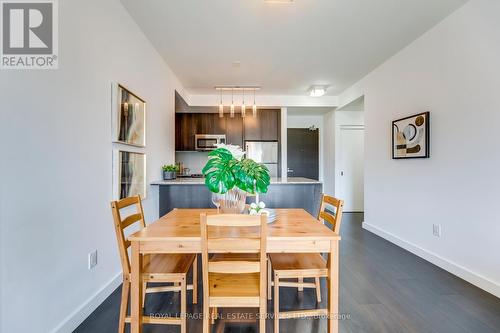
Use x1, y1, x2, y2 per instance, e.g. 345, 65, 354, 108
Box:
128, 209, 340, 333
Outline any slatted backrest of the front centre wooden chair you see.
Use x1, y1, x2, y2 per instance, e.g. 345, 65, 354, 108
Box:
200, 214, 267, 274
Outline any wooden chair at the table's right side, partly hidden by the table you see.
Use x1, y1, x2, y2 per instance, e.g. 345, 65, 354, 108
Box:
267, 195, 344, 333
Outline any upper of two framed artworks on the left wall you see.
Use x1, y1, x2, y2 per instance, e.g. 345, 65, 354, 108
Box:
112, 84, 146, 147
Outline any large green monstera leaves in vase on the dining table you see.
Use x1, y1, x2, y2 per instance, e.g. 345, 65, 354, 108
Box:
203, 145, 271, 213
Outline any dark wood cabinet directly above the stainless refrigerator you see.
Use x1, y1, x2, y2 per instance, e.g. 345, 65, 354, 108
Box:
243, 110, 281, 141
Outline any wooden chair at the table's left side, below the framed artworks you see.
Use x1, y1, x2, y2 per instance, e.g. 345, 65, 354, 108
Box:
111, 196, 198, 333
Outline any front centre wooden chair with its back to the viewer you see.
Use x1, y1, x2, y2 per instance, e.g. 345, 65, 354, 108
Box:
200, 214, 267, 333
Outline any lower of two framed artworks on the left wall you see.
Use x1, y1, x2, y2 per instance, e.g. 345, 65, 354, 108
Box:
113, 150, 146, 199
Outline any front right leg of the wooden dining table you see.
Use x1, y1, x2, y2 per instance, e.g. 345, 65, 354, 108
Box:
328, 241, 339, 333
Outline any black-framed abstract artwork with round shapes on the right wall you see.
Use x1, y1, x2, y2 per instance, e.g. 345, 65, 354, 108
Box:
392, 112, 430, 159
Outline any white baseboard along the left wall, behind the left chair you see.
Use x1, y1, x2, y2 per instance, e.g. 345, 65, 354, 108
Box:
51, 272, 122, 333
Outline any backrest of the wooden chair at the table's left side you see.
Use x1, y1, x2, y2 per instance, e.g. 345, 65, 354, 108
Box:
111, 195, 146, 274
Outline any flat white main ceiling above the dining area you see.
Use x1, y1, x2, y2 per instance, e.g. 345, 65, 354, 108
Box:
121, 0, 467, 95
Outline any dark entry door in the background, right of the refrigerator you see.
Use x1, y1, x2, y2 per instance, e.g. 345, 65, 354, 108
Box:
287, 128, 319, 180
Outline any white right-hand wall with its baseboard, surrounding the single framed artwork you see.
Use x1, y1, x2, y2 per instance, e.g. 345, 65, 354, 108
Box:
340, 0, 500, 296
